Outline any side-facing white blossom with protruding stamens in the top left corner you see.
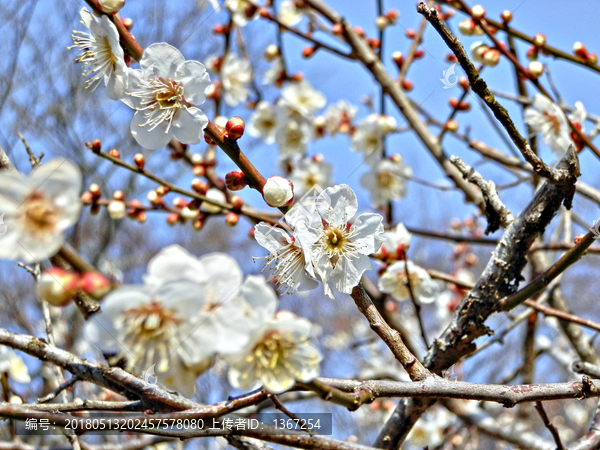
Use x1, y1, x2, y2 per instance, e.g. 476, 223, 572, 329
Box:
69, 8, 129, 100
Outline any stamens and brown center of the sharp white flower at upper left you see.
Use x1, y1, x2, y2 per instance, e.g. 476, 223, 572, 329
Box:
127, 77, 186, 133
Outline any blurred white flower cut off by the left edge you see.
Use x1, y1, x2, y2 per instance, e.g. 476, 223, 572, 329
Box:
0, 159, 82, 263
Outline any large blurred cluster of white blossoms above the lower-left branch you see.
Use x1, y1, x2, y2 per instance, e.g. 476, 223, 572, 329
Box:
86, 245, 321, 396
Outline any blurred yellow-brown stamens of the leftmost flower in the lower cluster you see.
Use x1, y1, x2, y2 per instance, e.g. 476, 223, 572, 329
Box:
116, 300, 181, 372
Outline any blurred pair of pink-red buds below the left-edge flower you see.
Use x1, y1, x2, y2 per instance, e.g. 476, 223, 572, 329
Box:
37, 267, 113, 306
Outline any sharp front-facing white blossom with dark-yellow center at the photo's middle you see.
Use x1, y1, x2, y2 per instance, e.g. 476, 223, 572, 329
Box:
296, 184, 383, 298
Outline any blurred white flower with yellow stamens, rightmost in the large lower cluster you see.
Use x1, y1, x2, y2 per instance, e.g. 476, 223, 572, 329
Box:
226, 312, 322, 394
